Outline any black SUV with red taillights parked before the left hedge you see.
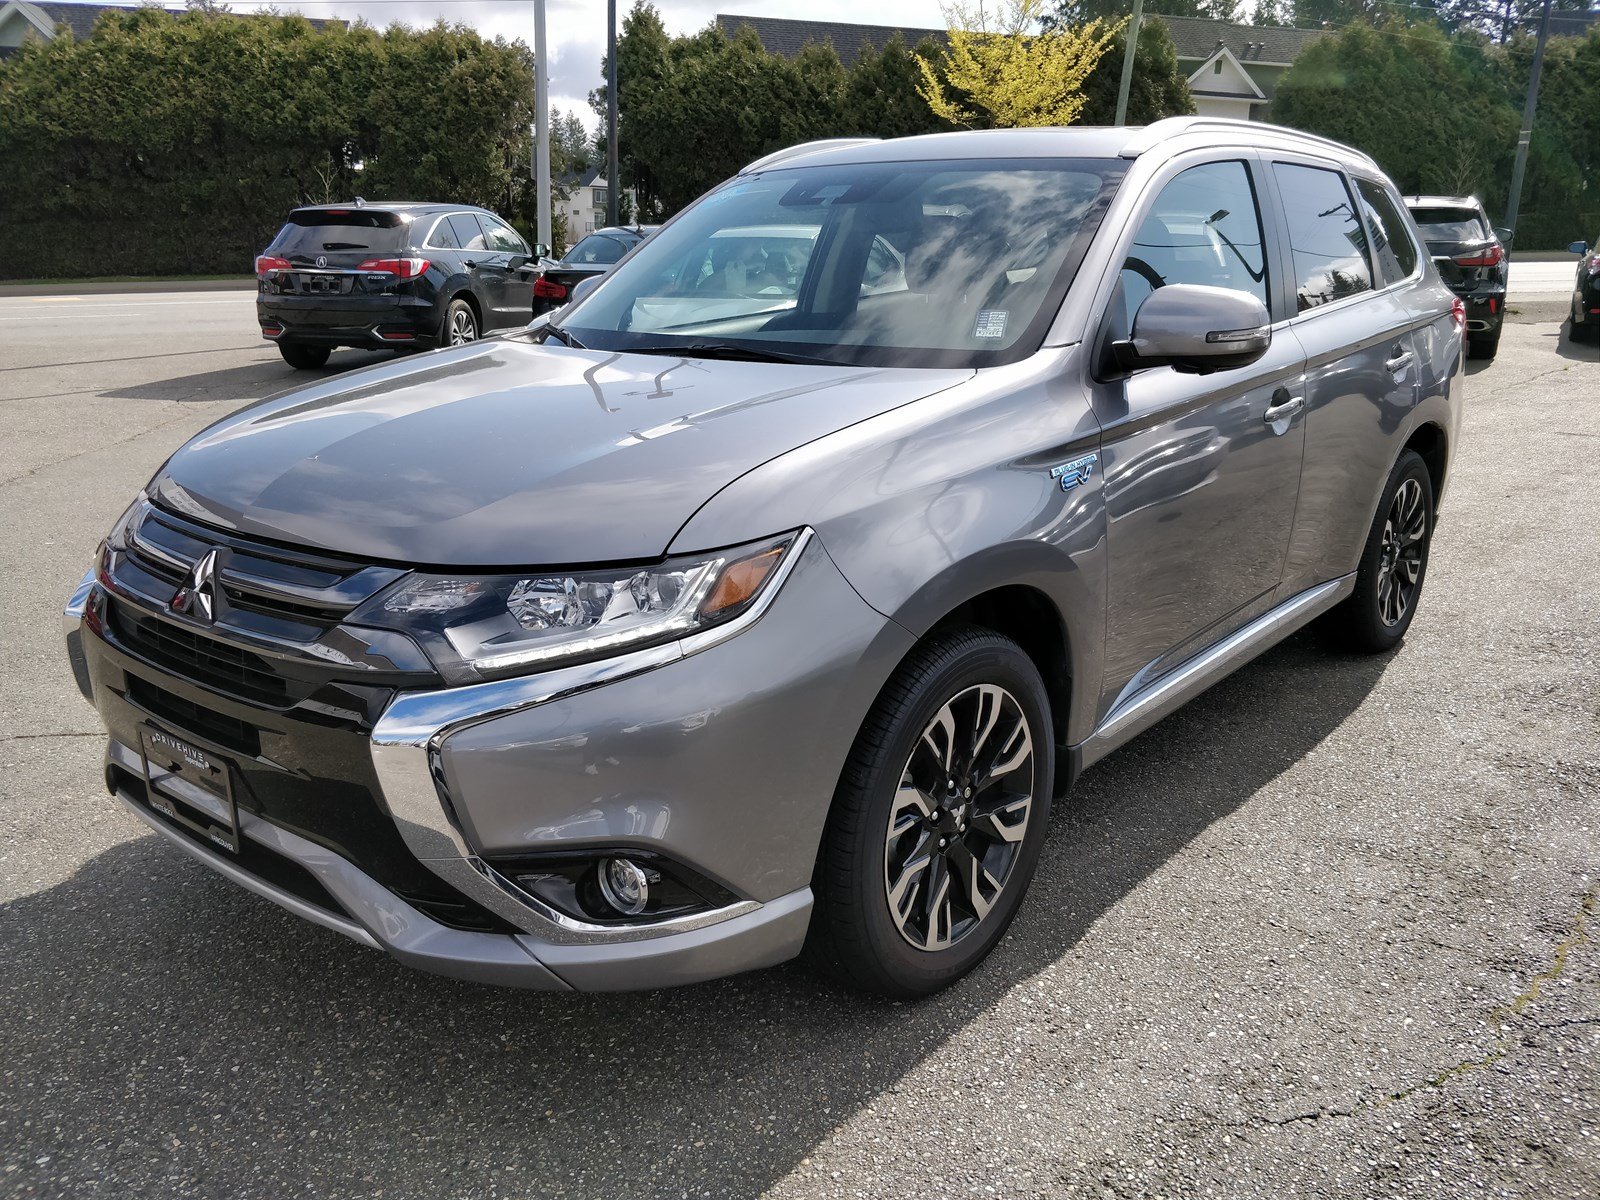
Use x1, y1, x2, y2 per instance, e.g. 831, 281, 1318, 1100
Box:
256, 200, 544, 368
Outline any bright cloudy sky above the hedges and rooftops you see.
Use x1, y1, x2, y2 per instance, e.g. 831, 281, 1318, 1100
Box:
224, 0, 944, 128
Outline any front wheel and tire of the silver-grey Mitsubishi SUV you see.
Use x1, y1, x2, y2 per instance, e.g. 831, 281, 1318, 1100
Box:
806, 627, 1054, 1000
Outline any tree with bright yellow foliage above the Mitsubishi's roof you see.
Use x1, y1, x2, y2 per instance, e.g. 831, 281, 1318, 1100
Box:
917, 0, 1123, 130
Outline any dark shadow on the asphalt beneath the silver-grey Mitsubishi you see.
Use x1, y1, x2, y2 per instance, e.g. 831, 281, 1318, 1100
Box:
0, 634, 1390, 1197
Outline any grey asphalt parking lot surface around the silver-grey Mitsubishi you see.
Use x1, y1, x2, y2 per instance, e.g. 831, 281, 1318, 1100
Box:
0, 293, 1600, 1200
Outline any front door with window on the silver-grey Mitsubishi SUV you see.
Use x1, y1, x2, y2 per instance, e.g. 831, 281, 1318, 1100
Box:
1094, 160, 1306, 712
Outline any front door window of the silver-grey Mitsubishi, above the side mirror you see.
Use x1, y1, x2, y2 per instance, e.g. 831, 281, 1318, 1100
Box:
1122, 162, 1267, 328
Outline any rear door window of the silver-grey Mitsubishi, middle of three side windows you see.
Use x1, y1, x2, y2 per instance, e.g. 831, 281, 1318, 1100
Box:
1272, 163, 1373, 312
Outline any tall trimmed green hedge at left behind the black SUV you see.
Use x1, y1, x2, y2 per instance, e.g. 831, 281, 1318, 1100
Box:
0, 8, 533, 278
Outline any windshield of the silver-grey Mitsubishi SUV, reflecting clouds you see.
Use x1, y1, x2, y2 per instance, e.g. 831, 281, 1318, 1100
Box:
562, 158, 1126, 366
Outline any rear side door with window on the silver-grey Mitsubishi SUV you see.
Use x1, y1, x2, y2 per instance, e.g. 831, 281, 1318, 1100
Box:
1270, 155, 1421, 595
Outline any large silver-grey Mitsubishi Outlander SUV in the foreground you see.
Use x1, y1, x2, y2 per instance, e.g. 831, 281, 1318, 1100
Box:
67, 118, 1464, 997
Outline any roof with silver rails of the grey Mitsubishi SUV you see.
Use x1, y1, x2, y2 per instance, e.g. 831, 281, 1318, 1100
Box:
742, 117, 1378, 173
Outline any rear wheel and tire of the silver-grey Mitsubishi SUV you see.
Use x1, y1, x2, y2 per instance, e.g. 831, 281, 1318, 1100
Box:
1325, 450, 1434, 654
